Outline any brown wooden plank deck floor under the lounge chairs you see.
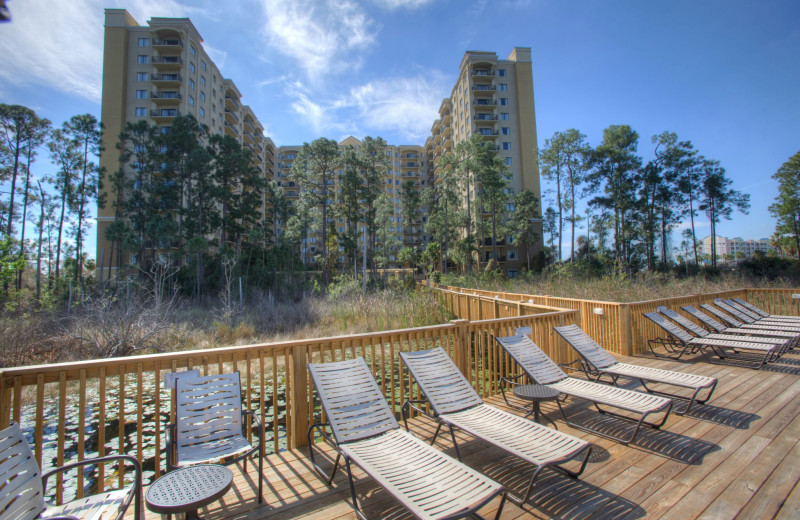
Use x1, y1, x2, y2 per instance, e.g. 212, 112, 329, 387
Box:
138, 353, 800, 520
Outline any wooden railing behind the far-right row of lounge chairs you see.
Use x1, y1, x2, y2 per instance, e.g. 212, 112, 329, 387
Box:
430, 284, 800, 356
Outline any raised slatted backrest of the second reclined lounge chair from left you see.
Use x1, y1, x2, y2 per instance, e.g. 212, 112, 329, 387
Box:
400, 347, 483, 415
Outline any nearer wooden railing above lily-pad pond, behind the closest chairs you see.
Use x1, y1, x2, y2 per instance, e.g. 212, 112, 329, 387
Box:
0, 302, 578, 502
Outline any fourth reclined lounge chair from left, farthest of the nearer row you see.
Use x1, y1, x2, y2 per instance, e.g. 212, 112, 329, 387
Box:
554, 325, 717, 415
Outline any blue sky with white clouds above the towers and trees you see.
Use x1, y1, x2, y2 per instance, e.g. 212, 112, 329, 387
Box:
0, 0, 800, 256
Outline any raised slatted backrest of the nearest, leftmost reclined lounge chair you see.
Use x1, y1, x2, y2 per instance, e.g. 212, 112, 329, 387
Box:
308, 357, 400, 444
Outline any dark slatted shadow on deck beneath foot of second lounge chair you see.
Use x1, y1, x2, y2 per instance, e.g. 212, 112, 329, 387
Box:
478, 456, 647, 519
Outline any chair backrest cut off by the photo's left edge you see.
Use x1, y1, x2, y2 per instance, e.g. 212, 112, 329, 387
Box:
0, 423, 45, 520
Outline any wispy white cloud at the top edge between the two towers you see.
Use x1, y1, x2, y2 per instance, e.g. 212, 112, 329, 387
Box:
262, 0, 375, 83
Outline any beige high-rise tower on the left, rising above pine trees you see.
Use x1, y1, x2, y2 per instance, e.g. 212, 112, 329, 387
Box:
97, 9, 275, 272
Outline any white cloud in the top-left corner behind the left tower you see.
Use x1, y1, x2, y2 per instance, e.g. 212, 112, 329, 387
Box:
0, 0, 208, 103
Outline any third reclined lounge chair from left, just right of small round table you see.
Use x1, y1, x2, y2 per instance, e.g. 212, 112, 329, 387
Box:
495, 336, 672, 444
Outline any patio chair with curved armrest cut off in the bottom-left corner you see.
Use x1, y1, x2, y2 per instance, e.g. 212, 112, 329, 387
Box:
0, 423, 143, 520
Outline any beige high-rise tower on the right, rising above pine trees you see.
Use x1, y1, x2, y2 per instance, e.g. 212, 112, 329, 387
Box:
425, 47, 542, 276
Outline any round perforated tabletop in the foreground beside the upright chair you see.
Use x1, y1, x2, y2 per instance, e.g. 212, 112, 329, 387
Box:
145, 464, 233, 520
